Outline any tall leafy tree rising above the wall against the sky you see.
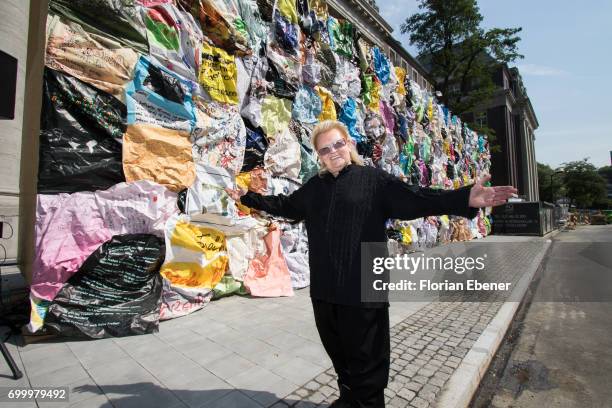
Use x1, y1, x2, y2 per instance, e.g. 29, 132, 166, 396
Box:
400, 0, 523, 120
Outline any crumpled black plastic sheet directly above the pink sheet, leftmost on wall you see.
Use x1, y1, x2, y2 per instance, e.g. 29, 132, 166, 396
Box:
38, 68, 126, 194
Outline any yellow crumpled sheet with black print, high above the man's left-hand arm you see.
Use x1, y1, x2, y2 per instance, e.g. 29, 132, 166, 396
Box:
199, 43, 238, 105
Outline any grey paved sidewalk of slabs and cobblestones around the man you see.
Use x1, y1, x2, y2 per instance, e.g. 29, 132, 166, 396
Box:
0, 237, 543, 408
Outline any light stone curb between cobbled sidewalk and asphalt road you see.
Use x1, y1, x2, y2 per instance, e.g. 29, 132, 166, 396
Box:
435, 236, 557, 408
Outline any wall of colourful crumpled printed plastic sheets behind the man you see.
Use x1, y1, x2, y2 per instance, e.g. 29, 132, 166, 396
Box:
29, 0, 490, 338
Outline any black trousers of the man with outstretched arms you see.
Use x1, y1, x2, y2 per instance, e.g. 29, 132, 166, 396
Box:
312, 299, 391, 408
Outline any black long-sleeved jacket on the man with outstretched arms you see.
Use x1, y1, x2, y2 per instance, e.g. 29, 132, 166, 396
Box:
241, 165, 478, 307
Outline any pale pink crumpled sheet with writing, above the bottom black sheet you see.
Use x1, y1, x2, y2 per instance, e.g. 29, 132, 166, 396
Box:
29, 180, 178, 332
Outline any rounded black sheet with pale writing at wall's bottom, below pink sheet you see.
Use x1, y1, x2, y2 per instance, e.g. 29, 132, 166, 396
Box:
45, 234, 165, 339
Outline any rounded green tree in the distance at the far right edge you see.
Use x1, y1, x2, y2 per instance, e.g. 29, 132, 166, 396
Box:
563, 158, 606, 208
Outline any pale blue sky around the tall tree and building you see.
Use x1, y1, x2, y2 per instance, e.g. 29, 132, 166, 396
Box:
376, 0, 612, 167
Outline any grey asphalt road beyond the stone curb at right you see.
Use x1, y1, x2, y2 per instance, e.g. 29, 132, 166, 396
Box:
473, 225, 612, 408
